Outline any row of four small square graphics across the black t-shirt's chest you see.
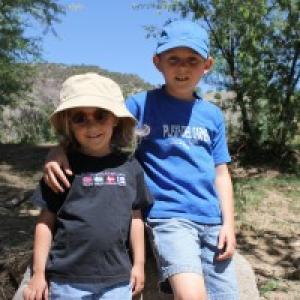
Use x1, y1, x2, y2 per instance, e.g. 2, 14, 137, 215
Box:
82, 172, 126, 186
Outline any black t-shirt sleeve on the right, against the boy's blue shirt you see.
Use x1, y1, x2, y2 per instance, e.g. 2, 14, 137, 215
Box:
132, 163, 153, 212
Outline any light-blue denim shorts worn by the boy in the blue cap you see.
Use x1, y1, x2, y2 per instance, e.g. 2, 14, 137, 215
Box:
147, 218, 239, 300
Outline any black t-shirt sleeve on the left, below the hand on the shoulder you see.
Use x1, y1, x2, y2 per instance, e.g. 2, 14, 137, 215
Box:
31, 179, 67, 214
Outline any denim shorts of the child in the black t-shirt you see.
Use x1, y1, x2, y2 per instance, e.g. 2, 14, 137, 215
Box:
49, 281, 132, 300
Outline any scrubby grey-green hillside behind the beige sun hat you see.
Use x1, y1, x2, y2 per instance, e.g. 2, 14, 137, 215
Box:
0, 63, 154, 144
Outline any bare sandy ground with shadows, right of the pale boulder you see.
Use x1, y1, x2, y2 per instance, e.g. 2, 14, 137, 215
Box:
237, 191, 300, 300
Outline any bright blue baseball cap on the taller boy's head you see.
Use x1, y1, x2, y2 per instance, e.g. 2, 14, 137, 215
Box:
156, 20, 209, 59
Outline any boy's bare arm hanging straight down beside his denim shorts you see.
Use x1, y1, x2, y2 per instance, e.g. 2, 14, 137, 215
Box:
215, 164, 236, 260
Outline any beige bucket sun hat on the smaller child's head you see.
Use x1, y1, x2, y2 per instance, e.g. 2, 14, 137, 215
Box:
50, 73, 136, 127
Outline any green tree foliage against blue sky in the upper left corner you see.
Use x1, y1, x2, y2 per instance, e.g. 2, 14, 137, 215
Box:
0, 0, 64, 105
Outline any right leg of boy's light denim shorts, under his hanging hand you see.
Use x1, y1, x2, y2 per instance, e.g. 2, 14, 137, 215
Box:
201, 225, 239, 300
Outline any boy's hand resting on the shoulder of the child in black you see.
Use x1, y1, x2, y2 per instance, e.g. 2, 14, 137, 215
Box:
43, 146, 72, 193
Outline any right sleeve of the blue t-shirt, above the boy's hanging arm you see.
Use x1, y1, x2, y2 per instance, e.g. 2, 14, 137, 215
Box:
212, 111, 231, 165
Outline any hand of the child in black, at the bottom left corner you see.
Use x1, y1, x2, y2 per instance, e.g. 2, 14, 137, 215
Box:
23, 274, 48, 300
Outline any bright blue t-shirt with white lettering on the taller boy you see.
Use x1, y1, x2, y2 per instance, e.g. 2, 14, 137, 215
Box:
126, 87, 230, 224
